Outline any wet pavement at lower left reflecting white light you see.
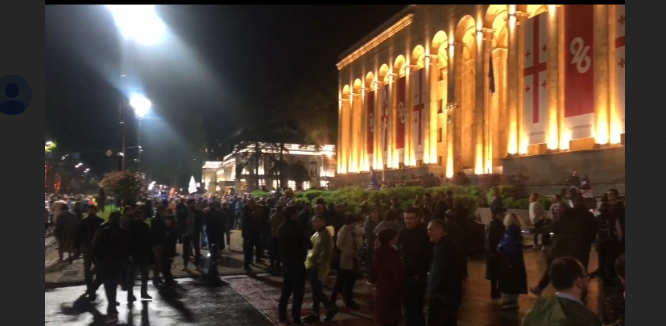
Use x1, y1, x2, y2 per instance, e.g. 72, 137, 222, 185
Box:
44, 280, 273, 326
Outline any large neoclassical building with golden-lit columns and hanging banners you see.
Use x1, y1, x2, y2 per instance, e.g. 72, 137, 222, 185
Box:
337, 5, 626, 192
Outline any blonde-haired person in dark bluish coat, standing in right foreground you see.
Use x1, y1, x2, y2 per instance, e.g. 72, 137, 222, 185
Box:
497, 213, 527, 310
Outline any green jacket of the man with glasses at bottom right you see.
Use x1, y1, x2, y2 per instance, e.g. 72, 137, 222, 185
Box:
521, 295, 602, 326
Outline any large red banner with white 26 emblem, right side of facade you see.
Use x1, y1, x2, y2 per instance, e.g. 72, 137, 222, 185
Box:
564, 5, 594, 118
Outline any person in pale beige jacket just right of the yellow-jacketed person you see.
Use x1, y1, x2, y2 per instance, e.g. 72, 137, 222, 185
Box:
330, 215, 363, 309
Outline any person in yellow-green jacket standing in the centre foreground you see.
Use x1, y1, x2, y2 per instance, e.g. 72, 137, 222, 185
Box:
303, 215, 338, 324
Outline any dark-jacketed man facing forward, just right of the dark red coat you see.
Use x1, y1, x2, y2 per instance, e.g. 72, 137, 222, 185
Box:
398, 208, 433, 326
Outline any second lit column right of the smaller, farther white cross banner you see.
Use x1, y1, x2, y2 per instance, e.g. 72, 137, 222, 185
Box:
444, 44, 460, 178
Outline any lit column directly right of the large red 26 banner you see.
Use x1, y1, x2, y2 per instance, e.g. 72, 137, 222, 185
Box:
593, 5, 614, 145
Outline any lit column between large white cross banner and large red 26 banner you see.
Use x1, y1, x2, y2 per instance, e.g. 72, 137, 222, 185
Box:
546, 8, 563, 150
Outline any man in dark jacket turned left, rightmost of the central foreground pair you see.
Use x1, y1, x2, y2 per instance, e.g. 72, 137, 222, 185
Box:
428, 220, 467, 326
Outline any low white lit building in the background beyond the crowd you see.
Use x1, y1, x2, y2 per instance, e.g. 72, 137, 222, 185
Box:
202, 143, 337, 192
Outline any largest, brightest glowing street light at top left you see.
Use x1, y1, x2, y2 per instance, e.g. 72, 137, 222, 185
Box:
106, 5, 166, 45
